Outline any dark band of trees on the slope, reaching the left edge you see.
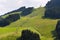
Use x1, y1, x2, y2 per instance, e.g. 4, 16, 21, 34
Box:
0, 14, 20, 27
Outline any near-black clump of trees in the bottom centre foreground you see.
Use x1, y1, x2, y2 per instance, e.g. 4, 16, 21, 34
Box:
17, 30, 40, 40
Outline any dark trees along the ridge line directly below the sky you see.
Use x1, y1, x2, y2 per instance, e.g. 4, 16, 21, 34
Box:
5, 6, 34, 16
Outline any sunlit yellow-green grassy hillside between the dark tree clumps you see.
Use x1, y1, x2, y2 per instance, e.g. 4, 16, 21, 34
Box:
0, 8, 57, 40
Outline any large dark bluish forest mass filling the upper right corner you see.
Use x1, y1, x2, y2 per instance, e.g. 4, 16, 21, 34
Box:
43, 0, 60, 19
